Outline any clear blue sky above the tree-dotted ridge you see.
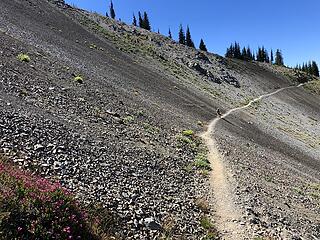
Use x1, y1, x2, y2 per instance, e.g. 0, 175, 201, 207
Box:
66, 0, 320, 66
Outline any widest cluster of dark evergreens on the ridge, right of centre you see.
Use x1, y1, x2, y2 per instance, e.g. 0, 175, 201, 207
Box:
225, 42, 284, 66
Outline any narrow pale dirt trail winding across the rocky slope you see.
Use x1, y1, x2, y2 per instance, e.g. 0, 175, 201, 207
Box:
201, 84, 304, 240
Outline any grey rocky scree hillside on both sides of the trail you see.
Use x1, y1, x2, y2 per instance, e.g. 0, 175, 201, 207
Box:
0, 0, 320, 239
